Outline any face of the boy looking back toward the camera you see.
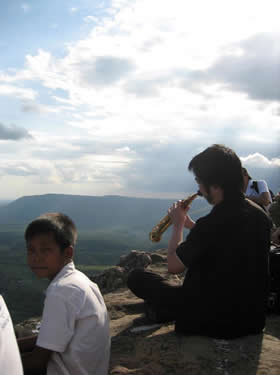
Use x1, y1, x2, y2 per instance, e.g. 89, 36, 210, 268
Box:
26, 233, 73, 280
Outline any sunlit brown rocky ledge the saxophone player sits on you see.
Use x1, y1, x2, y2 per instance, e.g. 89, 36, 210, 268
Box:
16, 249, 280, 375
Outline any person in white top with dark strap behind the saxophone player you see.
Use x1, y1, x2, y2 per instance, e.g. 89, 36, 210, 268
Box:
242, 167, 272, 211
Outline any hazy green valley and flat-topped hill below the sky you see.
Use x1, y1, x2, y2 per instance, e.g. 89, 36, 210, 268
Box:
0, 194, 209, 323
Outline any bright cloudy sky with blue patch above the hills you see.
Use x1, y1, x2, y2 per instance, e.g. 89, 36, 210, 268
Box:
0, 0, 280, 199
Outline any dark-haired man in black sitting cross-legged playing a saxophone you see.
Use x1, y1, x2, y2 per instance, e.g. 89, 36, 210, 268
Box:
128, 145, 271, 338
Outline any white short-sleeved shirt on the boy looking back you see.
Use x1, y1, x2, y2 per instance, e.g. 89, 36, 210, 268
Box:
36, 262, 110, 375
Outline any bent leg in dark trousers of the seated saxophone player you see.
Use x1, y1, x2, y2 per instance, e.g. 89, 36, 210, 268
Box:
127, 269, 183, 323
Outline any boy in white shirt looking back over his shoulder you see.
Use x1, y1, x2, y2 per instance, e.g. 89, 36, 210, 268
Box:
18, 213, 110, 375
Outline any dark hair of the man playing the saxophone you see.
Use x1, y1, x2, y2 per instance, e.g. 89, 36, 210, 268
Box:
188, 144, 244, 199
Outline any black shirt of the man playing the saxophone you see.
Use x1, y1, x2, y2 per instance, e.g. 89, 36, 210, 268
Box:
176, 197, 271, 338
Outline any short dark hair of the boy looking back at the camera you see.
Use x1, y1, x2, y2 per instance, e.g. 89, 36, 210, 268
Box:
24, 212, 78, 251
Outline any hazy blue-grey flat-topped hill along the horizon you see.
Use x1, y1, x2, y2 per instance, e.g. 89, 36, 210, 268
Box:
0, 194, 209, 229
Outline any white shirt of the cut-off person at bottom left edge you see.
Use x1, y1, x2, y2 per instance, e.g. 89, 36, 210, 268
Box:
0, 295, 23, 375
